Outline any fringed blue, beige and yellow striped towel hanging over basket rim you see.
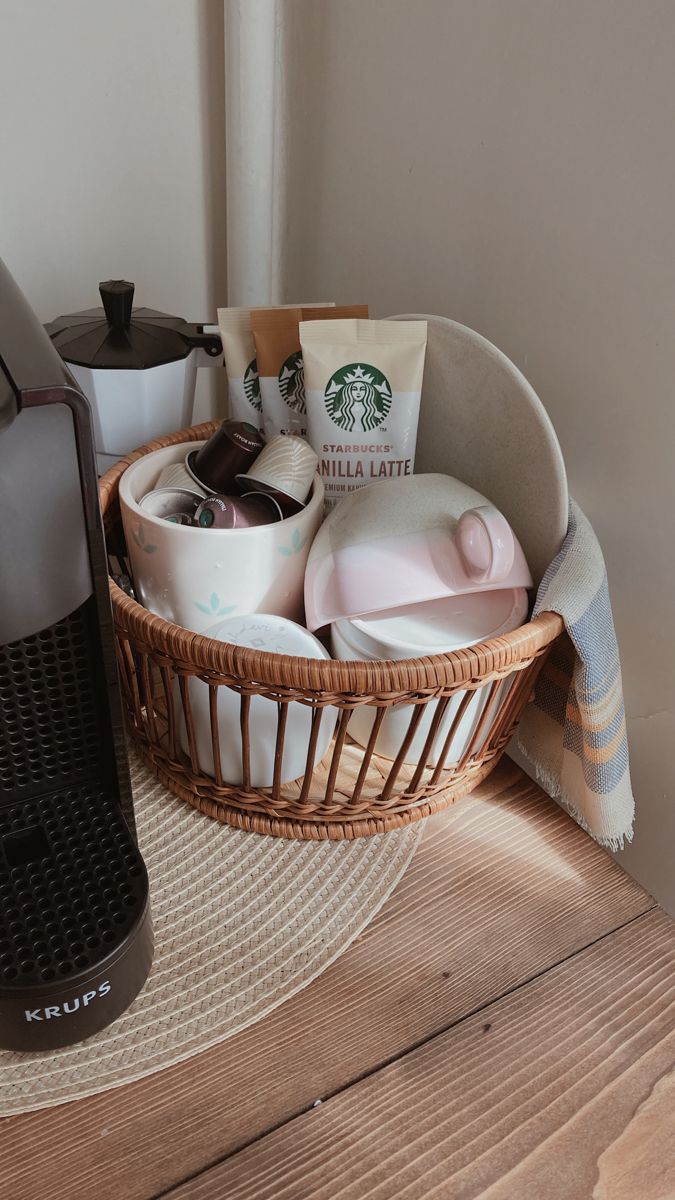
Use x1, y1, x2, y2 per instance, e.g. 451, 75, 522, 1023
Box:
514, 500, 634, 850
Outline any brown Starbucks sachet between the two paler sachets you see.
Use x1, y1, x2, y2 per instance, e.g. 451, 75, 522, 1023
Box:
251, 304, 368, 440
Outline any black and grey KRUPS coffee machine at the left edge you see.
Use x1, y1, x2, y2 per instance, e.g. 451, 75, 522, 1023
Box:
0, 262, 153, 1050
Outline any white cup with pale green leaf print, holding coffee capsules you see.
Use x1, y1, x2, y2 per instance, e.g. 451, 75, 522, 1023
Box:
119, 442, 323, 634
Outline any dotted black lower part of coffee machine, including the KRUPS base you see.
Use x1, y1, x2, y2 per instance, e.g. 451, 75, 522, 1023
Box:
0, 596, 151, 1050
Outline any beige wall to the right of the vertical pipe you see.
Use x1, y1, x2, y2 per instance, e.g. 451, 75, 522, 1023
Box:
283, 0, 675, 911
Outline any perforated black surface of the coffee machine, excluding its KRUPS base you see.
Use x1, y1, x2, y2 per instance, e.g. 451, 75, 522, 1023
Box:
0, 596, 147, 991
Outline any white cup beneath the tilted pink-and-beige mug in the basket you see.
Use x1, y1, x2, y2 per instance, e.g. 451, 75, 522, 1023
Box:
330, 588, 527, 767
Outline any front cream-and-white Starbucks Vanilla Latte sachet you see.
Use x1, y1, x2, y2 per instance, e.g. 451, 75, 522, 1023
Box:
300, 320, 426, 508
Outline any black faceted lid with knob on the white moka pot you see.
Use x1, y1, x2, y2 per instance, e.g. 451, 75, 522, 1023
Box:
44, 280, 222, 371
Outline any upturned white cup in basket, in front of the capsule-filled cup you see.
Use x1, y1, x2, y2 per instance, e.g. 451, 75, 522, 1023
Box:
174, 613, 338, 787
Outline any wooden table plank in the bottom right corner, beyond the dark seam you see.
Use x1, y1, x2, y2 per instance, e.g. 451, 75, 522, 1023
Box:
168, 912, 675, 1200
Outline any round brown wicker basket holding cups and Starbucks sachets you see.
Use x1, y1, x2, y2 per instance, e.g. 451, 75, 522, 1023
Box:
101, 424, 562, 839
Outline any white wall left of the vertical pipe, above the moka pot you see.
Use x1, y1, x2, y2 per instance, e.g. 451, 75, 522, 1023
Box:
0, 0, 226, 418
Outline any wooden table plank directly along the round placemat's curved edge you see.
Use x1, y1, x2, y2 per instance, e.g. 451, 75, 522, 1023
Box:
0, 761, 653, 1200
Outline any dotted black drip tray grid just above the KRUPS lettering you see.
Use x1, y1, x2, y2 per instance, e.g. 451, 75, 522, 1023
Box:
0, 786, 147, 988
